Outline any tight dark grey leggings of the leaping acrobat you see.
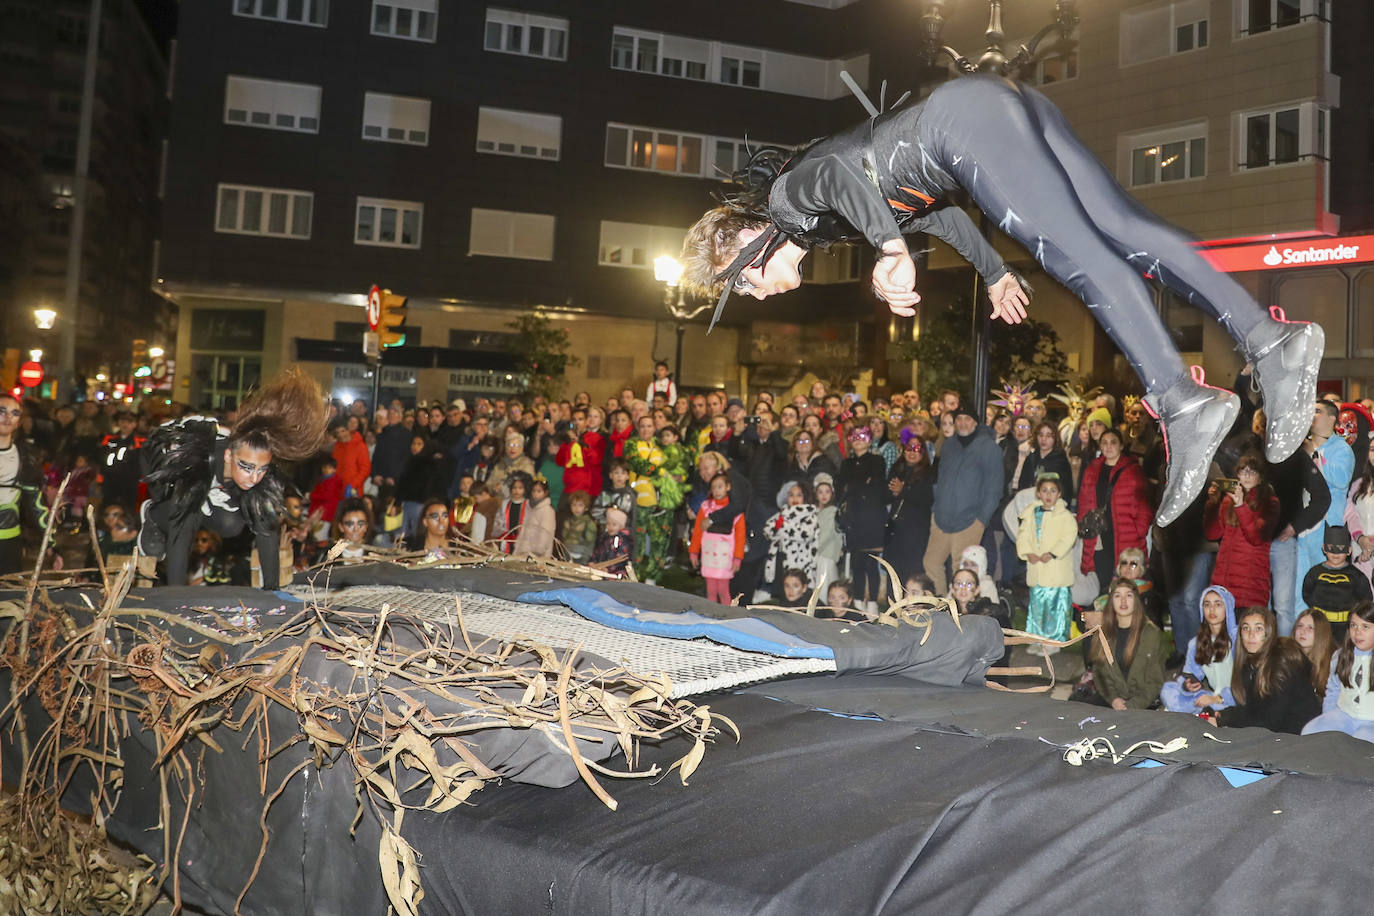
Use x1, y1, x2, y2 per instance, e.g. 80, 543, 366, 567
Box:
916, 76, 1265, 393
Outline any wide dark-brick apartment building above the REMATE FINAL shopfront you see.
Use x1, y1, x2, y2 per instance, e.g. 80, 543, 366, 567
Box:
157, 0, 901, 408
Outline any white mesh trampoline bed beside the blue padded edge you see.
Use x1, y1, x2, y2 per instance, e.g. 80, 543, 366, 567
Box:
289, 585, 835, 696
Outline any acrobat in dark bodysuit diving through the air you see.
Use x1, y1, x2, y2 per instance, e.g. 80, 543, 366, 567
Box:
683, 76, 1325, 525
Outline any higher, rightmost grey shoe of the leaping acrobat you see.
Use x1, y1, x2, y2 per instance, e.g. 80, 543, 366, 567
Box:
1241, 305, 1326, 464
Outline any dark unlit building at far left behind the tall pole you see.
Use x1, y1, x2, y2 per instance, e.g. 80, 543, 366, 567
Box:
0, 0, 173, 400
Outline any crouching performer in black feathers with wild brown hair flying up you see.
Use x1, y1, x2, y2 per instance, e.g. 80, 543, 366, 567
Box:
139, 368, 327, 591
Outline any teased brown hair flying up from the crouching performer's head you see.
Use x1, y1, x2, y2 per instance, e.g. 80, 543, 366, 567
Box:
229, 367, 328, 461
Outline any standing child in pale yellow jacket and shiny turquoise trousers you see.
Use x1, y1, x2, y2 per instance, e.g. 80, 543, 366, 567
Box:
1017, 474, 1079, 648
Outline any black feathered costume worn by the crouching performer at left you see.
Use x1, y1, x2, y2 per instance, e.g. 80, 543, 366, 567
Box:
139, 416, 284, 591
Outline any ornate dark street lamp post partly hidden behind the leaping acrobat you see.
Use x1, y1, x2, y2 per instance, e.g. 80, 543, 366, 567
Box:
921, 0, 1079, 416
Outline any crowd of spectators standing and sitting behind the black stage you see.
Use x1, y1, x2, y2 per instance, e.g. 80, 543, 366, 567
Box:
8, 364, 1374, 737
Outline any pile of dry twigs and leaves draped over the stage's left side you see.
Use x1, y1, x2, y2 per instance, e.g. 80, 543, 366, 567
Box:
0, 483, 739, 915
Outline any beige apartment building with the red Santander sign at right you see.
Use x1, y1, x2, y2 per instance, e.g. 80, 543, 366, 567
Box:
932, 0, 1374, 397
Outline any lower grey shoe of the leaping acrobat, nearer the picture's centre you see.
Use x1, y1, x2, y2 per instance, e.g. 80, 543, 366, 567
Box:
1143, 365, 1242, 527
